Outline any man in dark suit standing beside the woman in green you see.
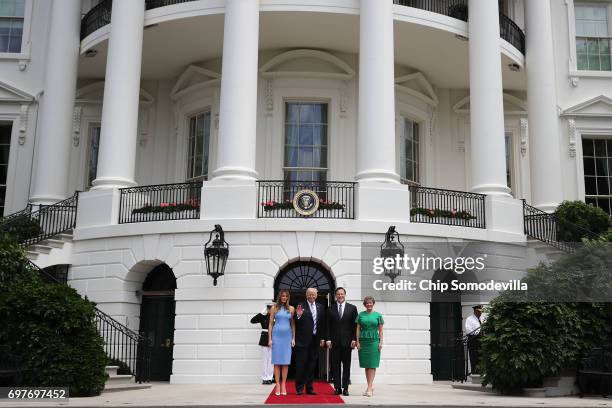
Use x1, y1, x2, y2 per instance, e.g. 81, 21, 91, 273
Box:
327, 287, 357, 396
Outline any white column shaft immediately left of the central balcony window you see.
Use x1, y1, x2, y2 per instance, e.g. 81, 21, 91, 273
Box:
213, 0, 259, 180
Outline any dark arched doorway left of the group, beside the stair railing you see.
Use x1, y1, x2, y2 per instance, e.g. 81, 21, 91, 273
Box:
140, 264, 176, 381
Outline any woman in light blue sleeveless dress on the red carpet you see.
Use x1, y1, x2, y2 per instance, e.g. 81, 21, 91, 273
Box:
268, 289, 295, 395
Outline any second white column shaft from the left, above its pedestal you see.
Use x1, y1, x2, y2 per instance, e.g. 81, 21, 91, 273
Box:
92, 0, 145, 189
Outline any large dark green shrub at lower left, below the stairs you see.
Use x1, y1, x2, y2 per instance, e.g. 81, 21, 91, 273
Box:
0, 279, 107, 397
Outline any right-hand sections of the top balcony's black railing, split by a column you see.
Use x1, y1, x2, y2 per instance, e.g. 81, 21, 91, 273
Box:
393, 0, 525, 54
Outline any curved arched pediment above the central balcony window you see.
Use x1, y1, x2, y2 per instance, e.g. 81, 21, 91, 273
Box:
259, 49, 355, 80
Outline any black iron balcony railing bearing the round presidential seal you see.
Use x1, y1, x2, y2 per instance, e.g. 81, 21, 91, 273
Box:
257, 180, 355, 219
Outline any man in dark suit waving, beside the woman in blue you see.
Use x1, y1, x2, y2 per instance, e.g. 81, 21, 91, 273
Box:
295, 288, 327, 395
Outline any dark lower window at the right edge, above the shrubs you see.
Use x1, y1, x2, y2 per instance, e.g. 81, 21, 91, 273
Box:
582, 138, 612, 214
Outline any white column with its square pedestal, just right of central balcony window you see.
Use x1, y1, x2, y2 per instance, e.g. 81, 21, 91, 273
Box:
355, 0, 410, 219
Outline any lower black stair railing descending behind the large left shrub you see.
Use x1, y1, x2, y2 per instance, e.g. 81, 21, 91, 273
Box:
28, 260, 152, 383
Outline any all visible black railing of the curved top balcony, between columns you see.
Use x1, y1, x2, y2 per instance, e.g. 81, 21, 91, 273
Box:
81, 0, 525, 54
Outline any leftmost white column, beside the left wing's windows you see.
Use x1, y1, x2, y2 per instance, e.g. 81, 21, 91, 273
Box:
30, 0, 81, 204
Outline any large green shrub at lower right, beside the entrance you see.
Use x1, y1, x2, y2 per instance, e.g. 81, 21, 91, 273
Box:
480, 242, 612, 392
